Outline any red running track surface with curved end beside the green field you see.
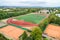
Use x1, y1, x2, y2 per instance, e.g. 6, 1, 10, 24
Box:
7, 19, 38, 27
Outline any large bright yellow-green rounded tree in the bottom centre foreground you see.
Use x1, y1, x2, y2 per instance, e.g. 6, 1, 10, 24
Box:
30, 27, 42, 40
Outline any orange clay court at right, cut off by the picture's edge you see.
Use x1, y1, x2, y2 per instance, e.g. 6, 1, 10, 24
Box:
44, 24, 60, 39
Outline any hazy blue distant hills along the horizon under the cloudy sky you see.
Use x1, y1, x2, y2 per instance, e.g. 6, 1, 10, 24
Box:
0, 6, 60, 8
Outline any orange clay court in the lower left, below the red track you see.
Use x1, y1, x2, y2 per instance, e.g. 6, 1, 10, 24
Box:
0, 25, 24, 40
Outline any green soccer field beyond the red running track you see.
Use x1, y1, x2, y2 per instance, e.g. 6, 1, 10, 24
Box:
15, 14, 45, 24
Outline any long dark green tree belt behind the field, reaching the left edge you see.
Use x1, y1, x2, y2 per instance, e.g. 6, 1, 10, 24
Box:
0, 8, 39, 19
